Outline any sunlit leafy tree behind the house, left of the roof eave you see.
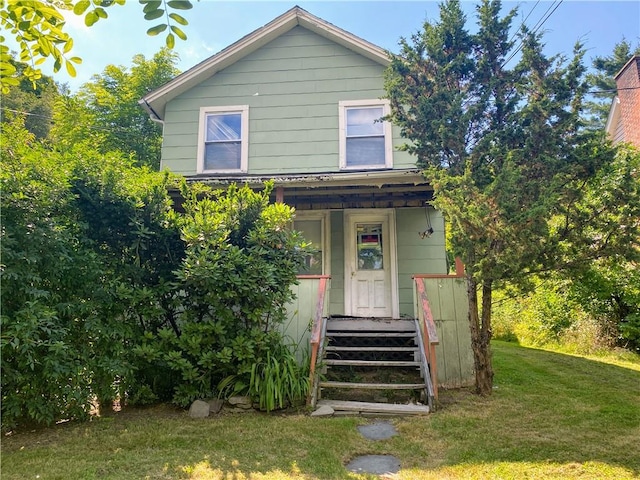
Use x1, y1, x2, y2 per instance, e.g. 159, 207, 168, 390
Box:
51, 48, 179, 170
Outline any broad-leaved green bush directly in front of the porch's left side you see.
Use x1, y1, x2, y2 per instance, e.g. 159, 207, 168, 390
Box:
135, 185, 306, 406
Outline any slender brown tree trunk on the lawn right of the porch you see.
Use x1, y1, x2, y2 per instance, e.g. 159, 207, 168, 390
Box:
467, 273, 493, 395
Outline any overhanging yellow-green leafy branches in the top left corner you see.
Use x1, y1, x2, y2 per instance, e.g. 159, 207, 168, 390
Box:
0, 0, 193, 93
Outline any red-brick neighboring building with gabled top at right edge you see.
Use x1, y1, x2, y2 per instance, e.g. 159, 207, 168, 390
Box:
606, 55, 640, 147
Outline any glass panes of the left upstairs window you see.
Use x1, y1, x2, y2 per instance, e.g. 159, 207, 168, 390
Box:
204, 113, 242, 170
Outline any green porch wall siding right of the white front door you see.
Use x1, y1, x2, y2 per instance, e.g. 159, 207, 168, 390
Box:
396, 207, 447, 316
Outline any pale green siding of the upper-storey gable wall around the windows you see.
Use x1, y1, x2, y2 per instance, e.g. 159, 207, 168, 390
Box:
162, 27, 415, 175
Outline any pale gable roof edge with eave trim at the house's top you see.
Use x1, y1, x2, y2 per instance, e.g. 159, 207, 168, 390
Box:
138, 6, 389, 120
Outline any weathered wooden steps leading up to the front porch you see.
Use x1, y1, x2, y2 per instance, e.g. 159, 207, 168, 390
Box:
316, 317, 429, 415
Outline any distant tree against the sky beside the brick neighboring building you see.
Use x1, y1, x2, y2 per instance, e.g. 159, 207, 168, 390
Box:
587, 38, 640, 129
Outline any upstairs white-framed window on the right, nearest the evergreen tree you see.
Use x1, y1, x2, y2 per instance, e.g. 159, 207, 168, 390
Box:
339, 100, 393, 170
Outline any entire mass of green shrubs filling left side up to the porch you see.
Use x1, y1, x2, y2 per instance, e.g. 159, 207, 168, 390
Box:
0, 123, 308, 429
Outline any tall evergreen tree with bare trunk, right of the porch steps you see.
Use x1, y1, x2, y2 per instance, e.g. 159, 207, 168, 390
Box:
386, 0, 638, 394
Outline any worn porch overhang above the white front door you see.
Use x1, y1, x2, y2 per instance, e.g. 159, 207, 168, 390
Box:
182, 169, 433, 210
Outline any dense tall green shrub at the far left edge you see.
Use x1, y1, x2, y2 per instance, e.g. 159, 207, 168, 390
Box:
0, 120, 126, 428
